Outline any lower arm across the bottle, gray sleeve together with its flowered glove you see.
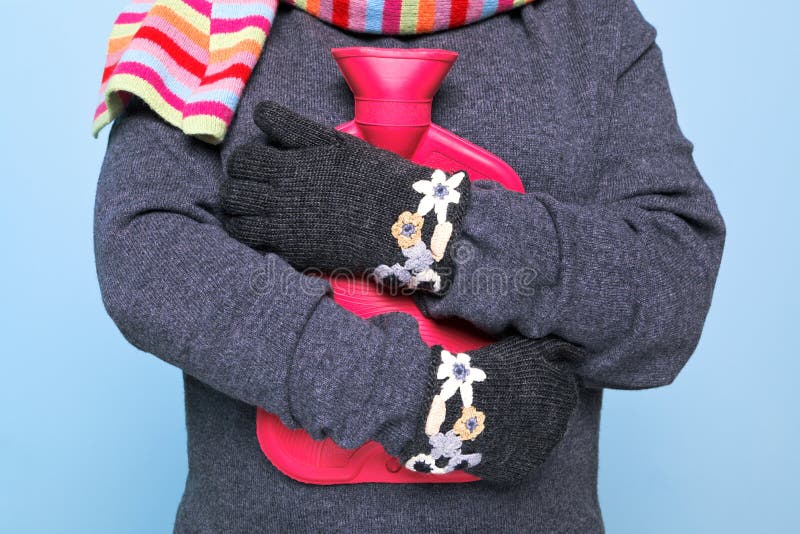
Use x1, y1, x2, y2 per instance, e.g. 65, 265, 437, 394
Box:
95, 102, 580, 483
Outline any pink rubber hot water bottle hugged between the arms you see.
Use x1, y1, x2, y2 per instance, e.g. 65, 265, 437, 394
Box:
256, 47, 523, 485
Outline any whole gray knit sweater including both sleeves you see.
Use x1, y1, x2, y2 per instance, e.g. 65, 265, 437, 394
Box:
95, 0, 724, 533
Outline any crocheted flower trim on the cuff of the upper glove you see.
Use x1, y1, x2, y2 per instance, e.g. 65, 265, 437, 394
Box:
372, 169, 470, 295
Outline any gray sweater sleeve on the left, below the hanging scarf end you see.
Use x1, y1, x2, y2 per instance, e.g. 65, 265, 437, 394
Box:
95, 101, 430, 451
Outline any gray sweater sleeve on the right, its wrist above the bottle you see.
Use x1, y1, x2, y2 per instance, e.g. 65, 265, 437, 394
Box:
412, 1, 725, 389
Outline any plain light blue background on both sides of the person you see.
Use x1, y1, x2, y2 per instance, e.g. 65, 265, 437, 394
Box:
0, 0, 800, 533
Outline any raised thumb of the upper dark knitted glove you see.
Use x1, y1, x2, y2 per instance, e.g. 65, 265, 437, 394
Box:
253, 100, 346, 148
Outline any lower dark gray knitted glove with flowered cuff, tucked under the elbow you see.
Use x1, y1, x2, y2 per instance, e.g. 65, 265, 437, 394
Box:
400, 336, 582, 484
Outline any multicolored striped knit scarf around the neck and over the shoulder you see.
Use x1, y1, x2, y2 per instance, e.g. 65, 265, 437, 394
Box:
93, 0, 533, 144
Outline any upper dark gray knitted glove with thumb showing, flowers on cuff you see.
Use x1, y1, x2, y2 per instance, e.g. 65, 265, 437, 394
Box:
221, 101, 470, 294
